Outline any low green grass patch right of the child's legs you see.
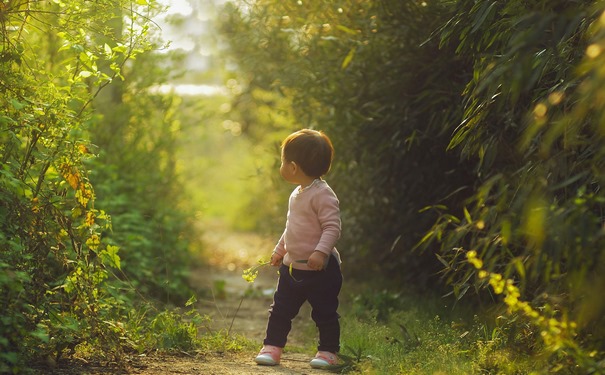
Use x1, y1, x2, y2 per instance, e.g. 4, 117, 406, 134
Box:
341, 291, 547, 375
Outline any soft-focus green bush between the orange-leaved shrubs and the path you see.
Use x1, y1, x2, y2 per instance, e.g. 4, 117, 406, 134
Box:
91, 89, 194, 301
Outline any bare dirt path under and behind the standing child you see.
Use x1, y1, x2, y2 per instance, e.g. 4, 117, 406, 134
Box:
38, 226, 336, 375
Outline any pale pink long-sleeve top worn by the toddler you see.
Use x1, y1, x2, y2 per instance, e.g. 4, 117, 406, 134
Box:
274, 179, 341, 271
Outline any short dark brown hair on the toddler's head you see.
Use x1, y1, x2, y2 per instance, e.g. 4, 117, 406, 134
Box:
281, 129, 334, 178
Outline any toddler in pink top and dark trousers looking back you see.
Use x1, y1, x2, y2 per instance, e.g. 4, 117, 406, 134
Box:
255, 129, 342, 369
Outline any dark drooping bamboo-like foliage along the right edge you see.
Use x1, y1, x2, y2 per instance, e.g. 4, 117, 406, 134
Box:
416, 2, 605, 371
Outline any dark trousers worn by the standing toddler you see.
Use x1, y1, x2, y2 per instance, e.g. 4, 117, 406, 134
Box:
263, 256, 342, 353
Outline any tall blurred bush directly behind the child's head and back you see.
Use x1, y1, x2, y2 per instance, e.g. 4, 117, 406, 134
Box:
218, 1, 470, 283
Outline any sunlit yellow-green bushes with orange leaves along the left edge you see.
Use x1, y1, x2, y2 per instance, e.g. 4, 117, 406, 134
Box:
0, 1, 196, 373
